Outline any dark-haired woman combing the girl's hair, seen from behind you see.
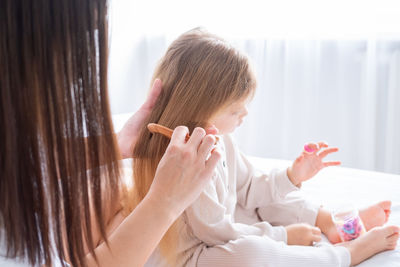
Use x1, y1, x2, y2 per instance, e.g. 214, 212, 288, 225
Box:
0, 0, 220, 266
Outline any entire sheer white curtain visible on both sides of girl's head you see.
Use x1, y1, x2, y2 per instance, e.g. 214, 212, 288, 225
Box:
110, 2, 400, 174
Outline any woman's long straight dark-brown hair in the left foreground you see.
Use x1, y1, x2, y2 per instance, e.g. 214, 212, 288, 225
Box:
0, 0, 119, 266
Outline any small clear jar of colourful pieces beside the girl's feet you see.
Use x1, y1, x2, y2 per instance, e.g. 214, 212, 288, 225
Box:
333, 210, 366, 241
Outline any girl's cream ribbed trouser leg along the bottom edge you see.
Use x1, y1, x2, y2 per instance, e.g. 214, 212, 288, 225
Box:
196, 236, 351, 267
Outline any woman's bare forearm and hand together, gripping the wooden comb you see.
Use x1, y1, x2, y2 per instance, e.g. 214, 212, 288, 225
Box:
87, 126, 221, 266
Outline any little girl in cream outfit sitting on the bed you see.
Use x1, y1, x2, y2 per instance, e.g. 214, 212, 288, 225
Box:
129, 29, 399, 267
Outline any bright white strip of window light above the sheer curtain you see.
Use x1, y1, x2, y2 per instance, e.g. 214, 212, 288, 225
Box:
112, 0, 400, 39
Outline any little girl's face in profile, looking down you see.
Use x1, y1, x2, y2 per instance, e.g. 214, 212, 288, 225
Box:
210, 99, 250, 134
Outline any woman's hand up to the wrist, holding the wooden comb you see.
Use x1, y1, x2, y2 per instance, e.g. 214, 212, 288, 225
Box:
146, 126, 221, 216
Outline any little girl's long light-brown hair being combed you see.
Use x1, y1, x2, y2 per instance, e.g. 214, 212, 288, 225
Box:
125, 29, 256, 262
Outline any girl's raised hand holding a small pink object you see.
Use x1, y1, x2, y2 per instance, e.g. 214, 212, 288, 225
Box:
287, 142, 341, 186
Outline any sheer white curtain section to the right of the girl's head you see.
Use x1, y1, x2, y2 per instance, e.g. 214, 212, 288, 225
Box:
230, 40, 400, 173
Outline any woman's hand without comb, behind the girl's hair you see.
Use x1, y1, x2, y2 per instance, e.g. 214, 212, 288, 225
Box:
117, 79, 162, 159
